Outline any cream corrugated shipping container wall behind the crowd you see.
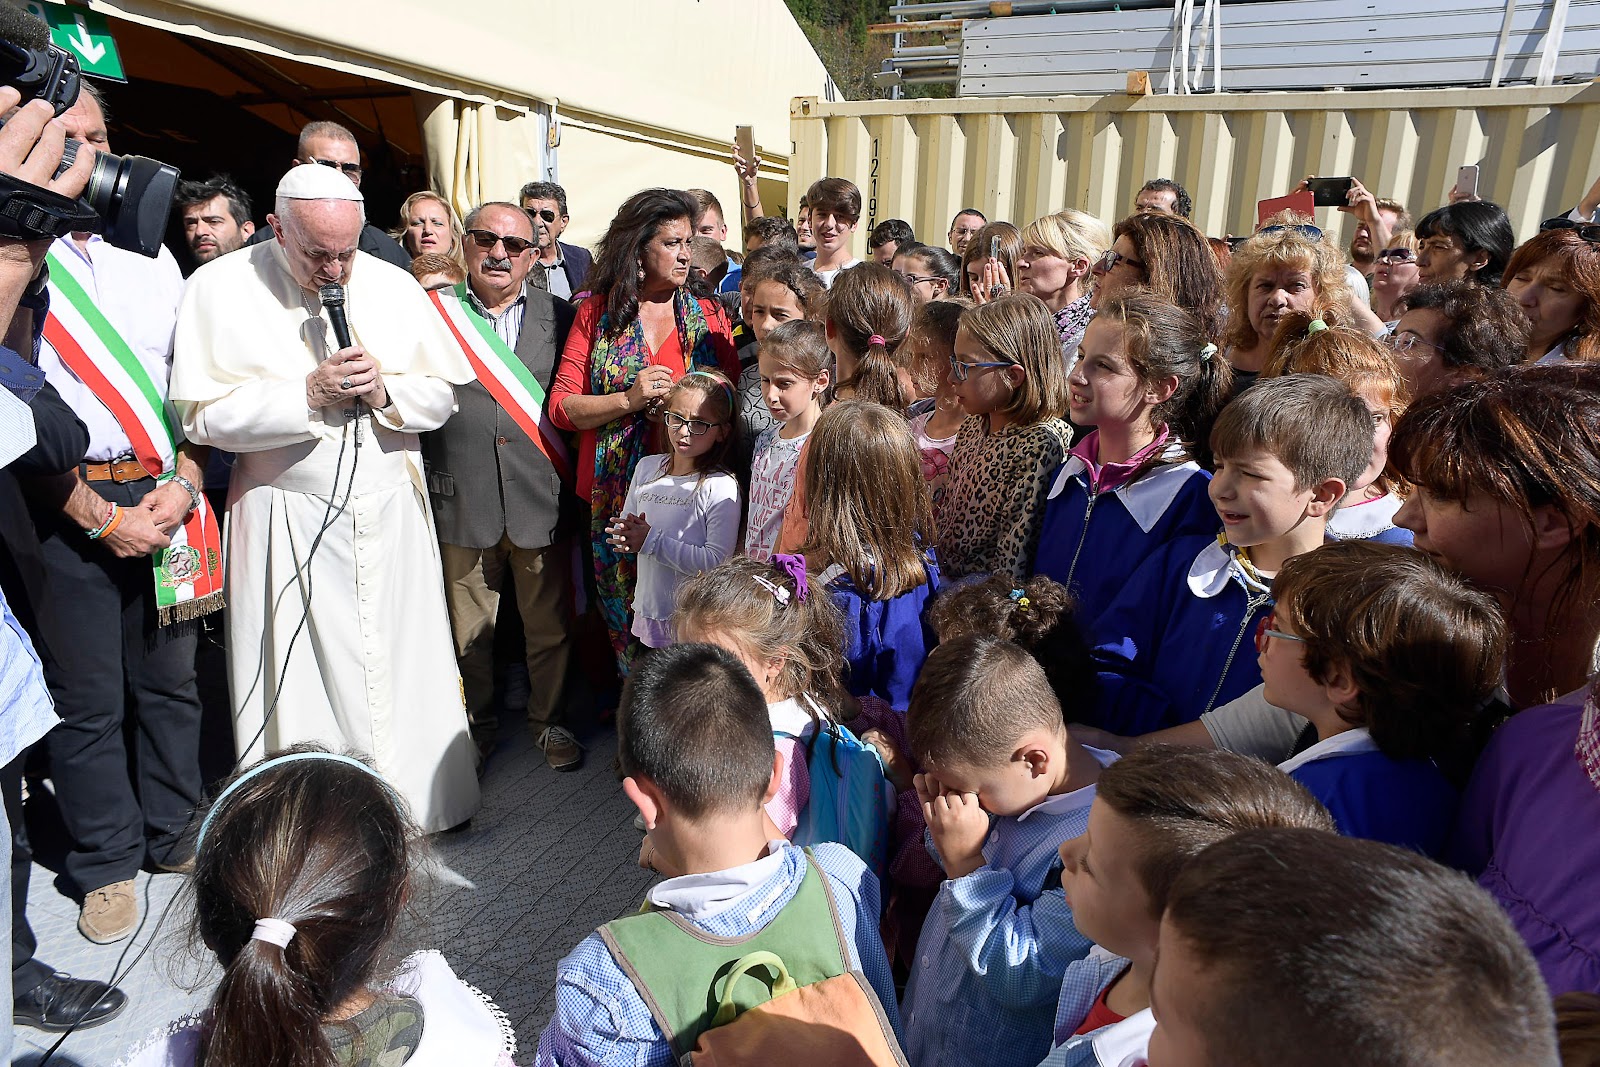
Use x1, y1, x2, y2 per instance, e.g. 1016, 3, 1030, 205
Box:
789, 83, 1600, 254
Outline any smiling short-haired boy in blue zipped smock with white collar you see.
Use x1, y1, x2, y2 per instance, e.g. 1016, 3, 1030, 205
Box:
1085, 374, 1373, 736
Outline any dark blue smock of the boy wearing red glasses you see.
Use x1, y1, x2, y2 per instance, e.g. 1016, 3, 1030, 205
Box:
1278, 726, 1459, 857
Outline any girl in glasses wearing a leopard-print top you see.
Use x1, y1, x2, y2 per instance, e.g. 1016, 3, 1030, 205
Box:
934, 294, 1068, 577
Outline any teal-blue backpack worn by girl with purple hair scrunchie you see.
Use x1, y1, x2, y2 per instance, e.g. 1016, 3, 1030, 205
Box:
774, 720, 894, 878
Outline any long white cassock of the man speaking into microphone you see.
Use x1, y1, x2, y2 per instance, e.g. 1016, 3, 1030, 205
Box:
171, 242, 478, 832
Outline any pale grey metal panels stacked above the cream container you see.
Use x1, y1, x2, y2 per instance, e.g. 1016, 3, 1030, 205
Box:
960, 0, 1600, 96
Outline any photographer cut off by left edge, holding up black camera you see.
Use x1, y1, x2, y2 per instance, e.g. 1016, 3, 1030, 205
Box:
0, 88, 128, 1036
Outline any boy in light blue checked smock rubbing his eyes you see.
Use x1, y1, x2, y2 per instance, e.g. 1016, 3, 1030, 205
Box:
902, 633, 1117, 1067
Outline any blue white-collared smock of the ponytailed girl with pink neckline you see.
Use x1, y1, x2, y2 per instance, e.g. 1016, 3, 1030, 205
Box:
1034, 441, 1216, 625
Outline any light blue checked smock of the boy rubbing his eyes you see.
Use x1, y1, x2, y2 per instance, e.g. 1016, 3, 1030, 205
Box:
901, 749, 1117, 1067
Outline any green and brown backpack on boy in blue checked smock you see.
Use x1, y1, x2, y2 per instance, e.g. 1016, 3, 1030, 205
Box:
600, 849, 907, 1067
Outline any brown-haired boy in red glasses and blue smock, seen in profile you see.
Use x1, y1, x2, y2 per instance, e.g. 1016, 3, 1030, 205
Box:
1259, 541, 1506, 857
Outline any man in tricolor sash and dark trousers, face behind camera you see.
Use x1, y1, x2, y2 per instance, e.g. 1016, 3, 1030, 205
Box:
35, 85, 208, 944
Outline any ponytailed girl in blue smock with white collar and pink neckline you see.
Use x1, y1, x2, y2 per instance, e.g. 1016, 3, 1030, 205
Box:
1035, 294, 1232, 621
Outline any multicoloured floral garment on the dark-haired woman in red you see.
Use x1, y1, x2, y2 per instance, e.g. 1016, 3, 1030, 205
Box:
589, 290, 718, 673
